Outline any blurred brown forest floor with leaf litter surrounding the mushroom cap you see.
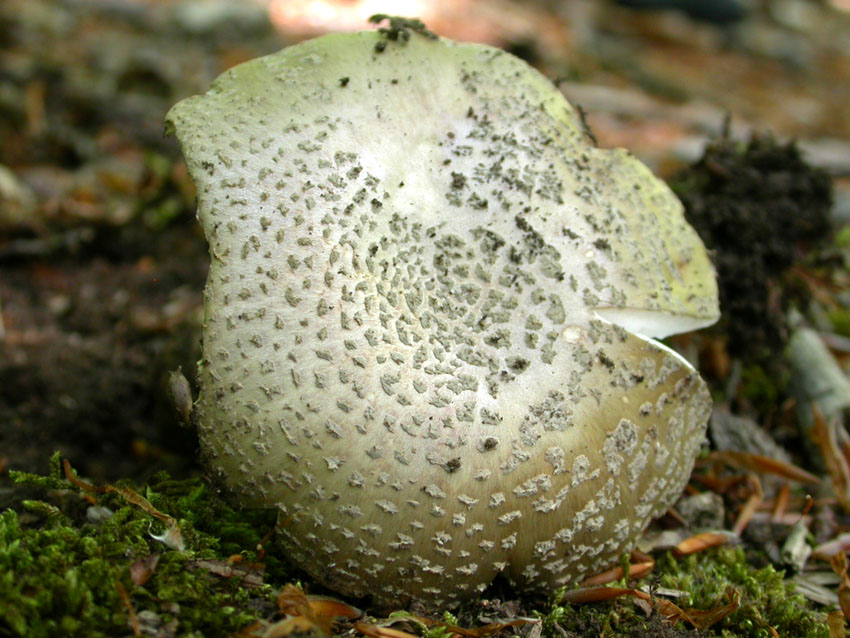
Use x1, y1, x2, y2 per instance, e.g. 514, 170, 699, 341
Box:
0, 0, 850, 638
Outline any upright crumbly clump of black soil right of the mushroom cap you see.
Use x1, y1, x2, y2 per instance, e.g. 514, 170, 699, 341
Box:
672, 136, 832, 362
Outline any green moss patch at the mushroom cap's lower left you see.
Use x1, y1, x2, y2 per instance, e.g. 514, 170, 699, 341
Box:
0, 456, 278, 638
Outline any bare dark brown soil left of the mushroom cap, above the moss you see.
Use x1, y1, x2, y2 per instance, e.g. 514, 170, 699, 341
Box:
0, 220, 206, 480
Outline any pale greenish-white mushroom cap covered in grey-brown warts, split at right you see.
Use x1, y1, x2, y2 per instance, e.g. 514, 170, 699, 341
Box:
167, 18, 718, 607
